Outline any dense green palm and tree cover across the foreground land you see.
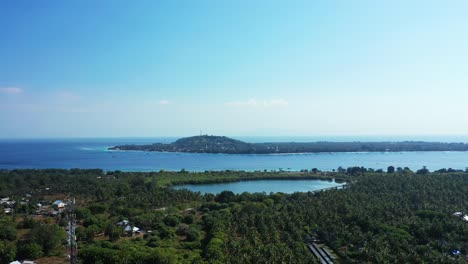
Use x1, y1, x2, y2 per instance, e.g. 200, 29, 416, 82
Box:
0, 167, 468, 263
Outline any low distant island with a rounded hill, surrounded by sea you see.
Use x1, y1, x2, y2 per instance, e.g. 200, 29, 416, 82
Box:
109, 135, 468, 154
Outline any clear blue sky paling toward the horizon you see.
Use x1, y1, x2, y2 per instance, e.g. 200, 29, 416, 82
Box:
0, 0, 468, 138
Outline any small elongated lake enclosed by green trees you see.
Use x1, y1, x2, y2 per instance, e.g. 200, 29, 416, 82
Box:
174, 180, 342, 194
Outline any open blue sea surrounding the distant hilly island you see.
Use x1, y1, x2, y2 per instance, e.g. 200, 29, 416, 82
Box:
0, 136, 468, 171
